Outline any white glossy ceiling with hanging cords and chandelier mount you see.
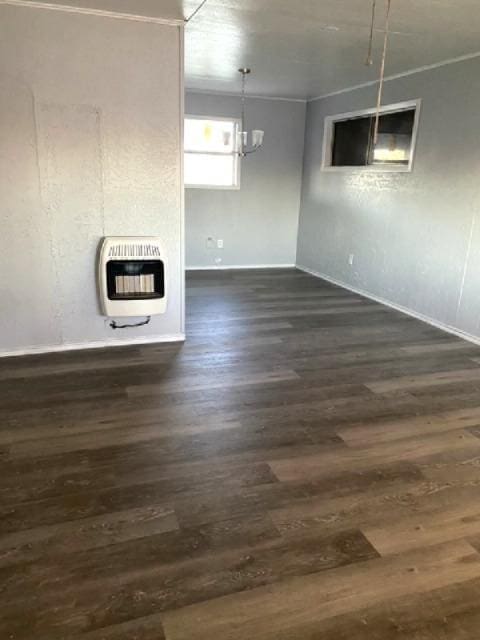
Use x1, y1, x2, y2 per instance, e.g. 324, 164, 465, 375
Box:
11, 0, 480, 98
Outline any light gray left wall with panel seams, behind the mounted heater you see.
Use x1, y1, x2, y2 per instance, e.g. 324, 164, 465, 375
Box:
0, 6, 183, 354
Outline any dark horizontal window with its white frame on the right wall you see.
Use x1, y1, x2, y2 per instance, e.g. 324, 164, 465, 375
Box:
323, 101, 419, 171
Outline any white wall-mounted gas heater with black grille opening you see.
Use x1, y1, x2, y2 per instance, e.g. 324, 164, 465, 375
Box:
98, 236, 167, 317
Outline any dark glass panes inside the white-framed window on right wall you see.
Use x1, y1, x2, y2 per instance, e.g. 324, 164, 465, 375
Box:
332, 109, 415, 167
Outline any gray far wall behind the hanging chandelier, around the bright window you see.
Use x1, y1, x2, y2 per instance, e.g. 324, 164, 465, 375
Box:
185, 93, 305, 268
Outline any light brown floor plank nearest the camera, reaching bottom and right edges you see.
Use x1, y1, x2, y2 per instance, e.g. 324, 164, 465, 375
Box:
163, 541, 480, 640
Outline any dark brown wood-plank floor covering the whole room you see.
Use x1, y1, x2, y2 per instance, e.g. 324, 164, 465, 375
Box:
4, 270, 480, 640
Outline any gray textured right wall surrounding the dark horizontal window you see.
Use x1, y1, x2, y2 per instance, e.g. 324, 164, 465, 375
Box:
297, 59, 480, 337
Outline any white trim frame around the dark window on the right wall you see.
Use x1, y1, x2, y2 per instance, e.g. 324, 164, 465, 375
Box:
321, 98, 422, 173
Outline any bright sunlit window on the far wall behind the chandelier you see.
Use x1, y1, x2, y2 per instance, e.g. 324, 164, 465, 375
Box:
184, 116, 240, 189
